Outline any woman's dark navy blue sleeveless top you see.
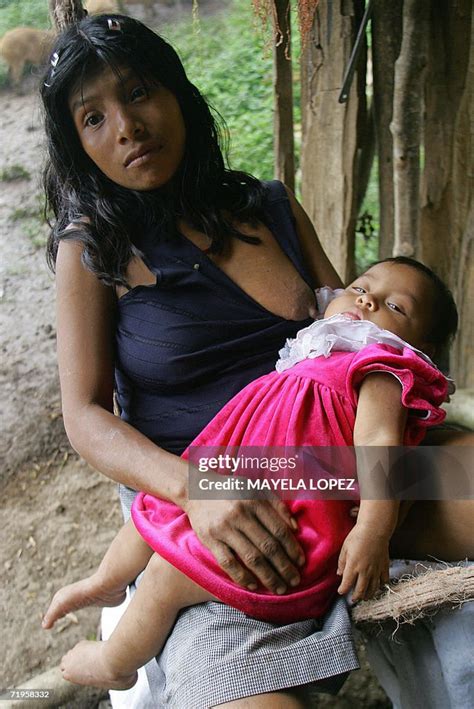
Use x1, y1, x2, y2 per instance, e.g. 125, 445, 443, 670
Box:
115, 181, 315, 455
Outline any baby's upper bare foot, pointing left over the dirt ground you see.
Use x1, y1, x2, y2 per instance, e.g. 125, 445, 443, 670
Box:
42, 576, 125, 630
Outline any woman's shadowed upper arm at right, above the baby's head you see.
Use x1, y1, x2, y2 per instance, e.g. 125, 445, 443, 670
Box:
285, 185, 342, 288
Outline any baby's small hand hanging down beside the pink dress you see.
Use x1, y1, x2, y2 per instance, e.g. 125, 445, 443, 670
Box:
337, 524, 389, 601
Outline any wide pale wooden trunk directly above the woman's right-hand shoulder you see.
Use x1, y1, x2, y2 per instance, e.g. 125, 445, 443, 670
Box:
301, 0, 366, 280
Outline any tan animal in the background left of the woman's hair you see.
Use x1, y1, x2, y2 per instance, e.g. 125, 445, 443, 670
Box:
0, 27, 54, 86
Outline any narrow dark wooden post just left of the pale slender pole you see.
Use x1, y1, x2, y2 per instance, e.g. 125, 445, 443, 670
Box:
372, 0, 403, 258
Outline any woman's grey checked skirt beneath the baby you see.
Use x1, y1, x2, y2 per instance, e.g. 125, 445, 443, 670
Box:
120, 486, 359, 709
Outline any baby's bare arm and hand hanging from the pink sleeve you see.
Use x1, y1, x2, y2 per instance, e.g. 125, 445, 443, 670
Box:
338, 372, 407, 601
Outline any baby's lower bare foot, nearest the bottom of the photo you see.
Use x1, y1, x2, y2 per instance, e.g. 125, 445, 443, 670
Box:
60, 640, 138, 689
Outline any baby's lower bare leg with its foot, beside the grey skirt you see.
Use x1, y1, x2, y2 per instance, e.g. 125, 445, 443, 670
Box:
61, 554, 217, 689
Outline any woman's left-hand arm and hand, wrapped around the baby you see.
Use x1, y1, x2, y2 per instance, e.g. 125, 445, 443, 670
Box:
56, 241, 302, 592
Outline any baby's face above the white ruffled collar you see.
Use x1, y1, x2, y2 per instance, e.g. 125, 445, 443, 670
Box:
324, 262, 433, 352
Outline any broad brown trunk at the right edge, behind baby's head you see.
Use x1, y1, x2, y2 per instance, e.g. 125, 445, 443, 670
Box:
420, 0, 474, 387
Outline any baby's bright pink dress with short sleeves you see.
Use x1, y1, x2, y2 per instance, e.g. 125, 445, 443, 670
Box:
132, 344, 447, 623
